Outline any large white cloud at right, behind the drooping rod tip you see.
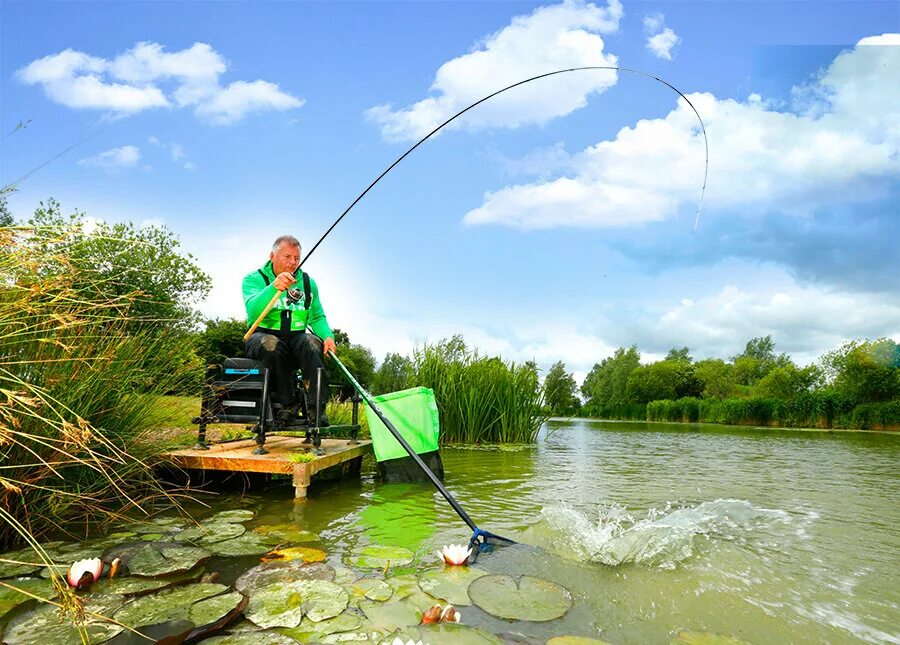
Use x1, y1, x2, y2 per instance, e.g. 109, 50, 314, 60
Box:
464, 34, 900, 229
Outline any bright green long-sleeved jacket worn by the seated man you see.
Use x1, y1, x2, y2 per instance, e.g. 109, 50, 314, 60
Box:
241, 261, 334, 339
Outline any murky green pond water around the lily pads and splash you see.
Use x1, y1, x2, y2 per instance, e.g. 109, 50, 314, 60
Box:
1, 420, 900, 645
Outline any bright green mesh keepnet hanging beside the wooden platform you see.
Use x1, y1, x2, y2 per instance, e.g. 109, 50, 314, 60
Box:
366, 387, 440, 461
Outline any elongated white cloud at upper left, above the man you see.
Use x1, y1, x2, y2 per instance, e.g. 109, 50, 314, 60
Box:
16, 42, 304, 124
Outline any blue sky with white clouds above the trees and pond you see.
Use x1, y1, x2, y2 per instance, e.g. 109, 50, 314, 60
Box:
0, 0, 900, 377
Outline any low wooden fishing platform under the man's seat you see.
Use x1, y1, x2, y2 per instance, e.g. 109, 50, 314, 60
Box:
165, 435, 372, 499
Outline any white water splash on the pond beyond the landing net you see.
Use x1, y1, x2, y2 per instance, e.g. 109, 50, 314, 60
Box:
528, 499, 789, 568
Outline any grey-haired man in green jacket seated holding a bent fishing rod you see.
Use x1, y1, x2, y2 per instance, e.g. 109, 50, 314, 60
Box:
241, 235, 335, 428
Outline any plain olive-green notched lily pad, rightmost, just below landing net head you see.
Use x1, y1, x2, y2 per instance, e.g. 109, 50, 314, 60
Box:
469, 575, 572, 622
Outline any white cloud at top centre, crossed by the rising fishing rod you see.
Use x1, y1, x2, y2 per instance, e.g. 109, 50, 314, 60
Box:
366, 0, 622, 141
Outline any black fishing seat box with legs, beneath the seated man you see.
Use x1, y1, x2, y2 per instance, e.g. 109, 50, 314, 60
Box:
192, 358, 359, 455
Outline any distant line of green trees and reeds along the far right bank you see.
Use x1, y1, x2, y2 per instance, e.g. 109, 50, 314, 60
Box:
564, 336, 900, 429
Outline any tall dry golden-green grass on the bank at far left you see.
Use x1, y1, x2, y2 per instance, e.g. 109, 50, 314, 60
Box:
0, 227, 194, 547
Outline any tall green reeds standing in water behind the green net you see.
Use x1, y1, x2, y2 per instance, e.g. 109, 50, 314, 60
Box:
411, 338, 547, 443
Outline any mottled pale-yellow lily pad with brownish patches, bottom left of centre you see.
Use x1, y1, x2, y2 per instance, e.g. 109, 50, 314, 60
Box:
244, 580, 350, 627
